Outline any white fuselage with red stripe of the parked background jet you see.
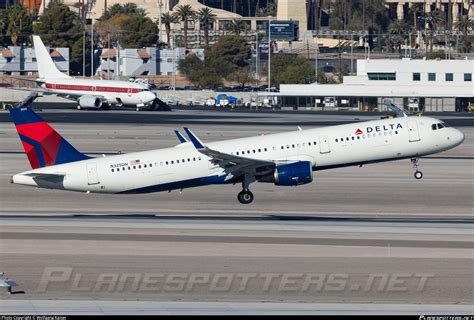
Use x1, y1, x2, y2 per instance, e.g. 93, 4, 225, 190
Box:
41, 78, 156, 106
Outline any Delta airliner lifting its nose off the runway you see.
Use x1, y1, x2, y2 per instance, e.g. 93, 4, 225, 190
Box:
10, 105, 464, 204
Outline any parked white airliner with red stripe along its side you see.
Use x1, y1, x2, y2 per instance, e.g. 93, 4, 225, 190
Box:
17, 35, 163, 111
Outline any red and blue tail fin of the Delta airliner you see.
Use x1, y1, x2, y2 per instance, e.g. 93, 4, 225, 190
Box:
10, 107, 89, 169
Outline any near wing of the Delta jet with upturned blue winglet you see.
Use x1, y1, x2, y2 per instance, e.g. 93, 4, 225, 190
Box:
184, 128, 276, 176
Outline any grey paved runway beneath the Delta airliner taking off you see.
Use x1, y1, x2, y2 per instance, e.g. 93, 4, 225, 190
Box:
0, 111, 474, 314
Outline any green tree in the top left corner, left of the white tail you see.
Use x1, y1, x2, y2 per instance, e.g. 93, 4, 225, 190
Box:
1, 5, 32, 45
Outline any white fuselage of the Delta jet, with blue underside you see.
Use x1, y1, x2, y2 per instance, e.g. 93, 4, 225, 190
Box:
12, 117, 464, 193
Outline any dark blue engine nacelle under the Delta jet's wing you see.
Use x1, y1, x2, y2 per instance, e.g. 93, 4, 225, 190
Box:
258, 161, 313, 186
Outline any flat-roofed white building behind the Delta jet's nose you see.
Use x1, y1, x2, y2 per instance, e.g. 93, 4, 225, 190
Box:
274, 58, 474, 111
